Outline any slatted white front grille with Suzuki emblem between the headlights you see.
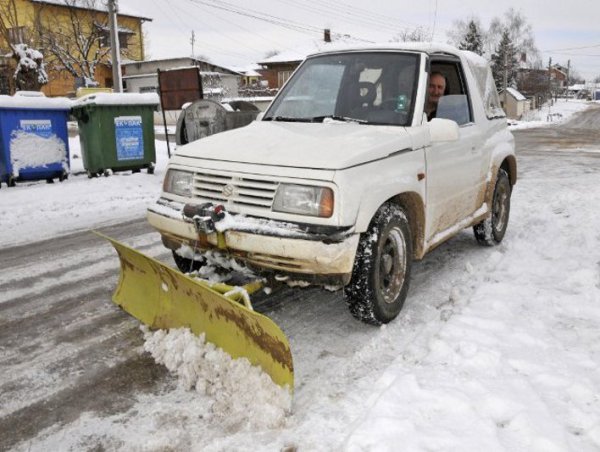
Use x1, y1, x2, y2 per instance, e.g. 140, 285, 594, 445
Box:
193, 172, 279, 210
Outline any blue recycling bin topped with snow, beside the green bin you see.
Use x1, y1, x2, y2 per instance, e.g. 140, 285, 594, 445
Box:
0, 93, 71, 187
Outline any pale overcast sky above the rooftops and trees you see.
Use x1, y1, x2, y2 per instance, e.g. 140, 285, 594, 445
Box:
119, 0, 600, 79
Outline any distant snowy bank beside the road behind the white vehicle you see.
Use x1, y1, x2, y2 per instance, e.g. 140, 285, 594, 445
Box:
508, 99, 592, 130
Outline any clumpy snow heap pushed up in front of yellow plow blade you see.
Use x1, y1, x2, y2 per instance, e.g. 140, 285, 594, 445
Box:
142, 327, 292, 429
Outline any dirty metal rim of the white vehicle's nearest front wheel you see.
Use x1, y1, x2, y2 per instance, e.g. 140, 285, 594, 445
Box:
377, 227, 406, 304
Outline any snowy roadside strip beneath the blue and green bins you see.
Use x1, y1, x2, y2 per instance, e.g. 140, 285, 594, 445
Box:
0, 127, 173, 246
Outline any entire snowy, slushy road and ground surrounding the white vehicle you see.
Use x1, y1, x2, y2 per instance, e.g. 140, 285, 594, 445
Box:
0, 103, 600, 452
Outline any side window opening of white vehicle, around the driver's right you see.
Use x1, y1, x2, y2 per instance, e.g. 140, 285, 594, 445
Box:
431, 61, 473, 126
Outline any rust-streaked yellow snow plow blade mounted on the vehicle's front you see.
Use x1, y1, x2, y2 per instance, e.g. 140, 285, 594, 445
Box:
95, 232, 294, 391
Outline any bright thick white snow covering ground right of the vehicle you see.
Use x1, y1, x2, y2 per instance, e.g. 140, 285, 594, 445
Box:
346, 154, 600, 452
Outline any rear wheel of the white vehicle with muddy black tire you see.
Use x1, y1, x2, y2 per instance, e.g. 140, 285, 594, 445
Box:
473, 168, 512, 246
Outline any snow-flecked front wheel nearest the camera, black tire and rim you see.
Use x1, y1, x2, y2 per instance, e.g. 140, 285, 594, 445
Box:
344, 204, 413, 325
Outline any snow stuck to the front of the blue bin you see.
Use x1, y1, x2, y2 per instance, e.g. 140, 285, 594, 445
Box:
10, 130, 69, 177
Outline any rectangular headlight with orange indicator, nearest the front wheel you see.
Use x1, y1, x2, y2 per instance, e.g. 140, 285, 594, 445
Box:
273, 184, 333, 218
